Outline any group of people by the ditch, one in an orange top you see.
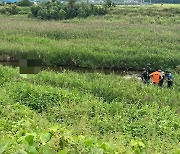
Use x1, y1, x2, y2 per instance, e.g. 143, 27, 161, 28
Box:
141, 64, 173, 88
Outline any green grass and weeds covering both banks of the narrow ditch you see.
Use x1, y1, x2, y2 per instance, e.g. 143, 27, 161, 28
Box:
0, 5, 180, 154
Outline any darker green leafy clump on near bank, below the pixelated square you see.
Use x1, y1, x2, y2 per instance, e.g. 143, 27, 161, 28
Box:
6, 82, 61, 112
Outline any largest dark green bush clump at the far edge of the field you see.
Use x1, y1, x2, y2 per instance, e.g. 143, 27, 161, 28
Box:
29, 0, 107, 20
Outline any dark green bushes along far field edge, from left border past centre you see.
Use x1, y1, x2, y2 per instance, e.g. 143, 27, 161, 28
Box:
0, 0, 107, 20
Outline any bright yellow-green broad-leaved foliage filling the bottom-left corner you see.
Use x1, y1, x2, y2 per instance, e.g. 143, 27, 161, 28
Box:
0, 89, 125, 154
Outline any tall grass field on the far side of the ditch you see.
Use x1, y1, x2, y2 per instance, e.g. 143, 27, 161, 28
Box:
0, 5, 180, 69
